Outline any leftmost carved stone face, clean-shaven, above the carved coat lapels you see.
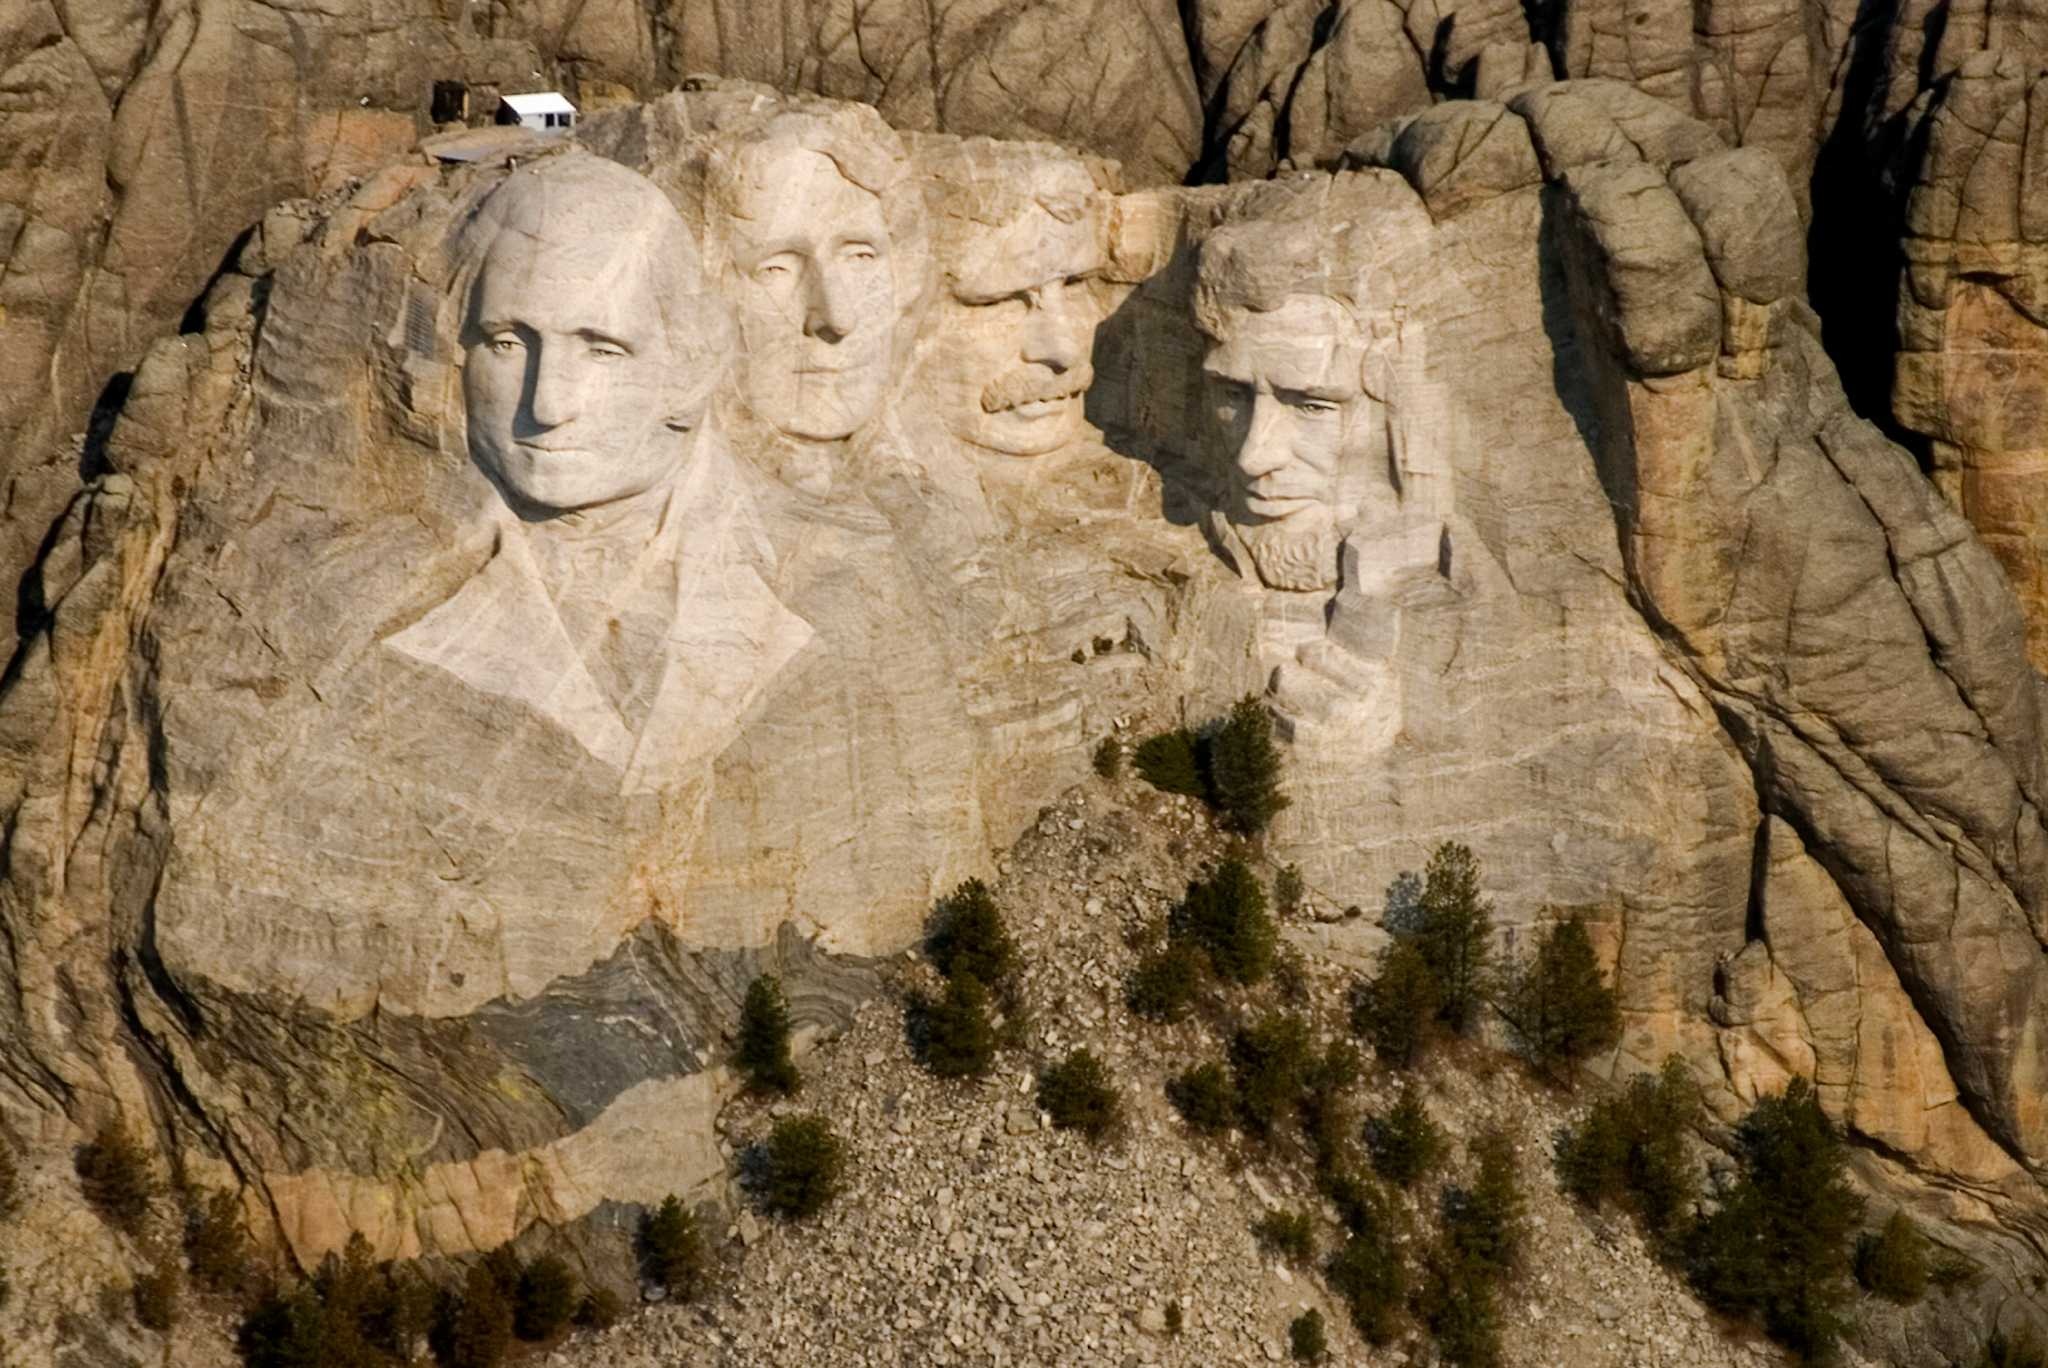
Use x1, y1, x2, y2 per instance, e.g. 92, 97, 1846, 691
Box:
463, 178, 694, 516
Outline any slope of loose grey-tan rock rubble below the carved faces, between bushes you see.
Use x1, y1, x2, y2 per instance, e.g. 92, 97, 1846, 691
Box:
547, 780, 1826, 1368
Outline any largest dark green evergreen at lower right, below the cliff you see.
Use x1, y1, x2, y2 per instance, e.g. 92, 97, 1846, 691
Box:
1688, 1079, 1862, 1358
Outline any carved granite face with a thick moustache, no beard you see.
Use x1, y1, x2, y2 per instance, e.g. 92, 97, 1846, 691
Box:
926, 205, 1104, 457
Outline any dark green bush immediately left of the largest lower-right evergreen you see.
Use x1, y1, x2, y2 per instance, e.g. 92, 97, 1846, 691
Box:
1556, 1057, 1700, 1249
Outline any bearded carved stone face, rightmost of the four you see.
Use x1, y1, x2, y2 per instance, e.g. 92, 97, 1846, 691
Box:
1202, 295, 1374, 590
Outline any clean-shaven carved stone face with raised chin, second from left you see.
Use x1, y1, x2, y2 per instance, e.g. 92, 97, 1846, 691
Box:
729, 145, 897, 440
